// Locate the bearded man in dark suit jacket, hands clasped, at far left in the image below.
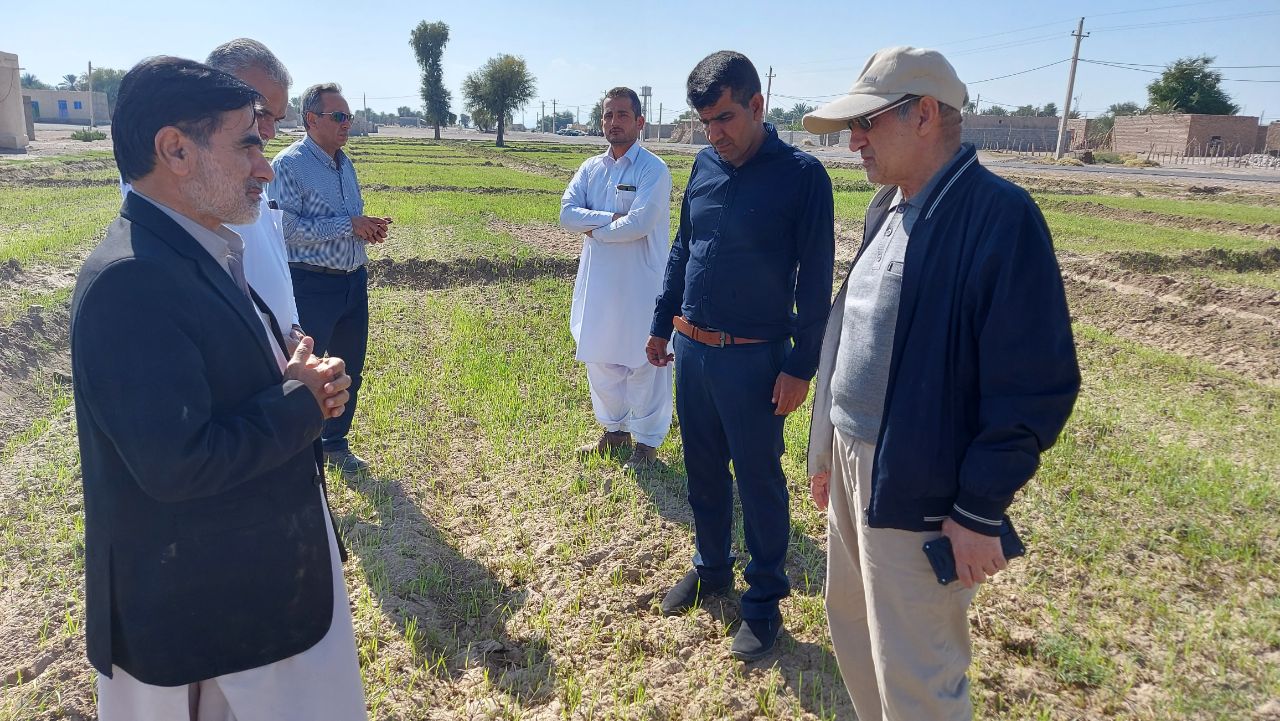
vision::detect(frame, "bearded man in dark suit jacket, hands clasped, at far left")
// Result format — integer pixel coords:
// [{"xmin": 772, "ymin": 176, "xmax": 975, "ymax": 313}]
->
[{"xmin": 70, "ymin": 58, "xmax": 365, "ymax": 721}]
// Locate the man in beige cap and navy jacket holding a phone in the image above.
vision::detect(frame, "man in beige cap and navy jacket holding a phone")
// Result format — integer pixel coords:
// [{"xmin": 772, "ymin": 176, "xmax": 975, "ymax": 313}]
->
[{"xmin": 804, "ymin": 47, "xmax": 1080, "ymax": 721}]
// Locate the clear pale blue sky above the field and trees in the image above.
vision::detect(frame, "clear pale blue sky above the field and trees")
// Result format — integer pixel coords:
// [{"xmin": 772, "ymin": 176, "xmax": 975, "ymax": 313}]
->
[{"xmin": 12, "ymin": 0, "xmax": 1280, "ymax": 122}]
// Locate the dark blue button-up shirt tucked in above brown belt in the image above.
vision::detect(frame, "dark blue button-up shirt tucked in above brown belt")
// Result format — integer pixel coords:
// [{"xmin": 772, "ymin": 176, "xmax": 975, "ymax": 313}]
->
[{"xmin": 650, "ymin": 124, "xmax": 836, "ymax": 380}]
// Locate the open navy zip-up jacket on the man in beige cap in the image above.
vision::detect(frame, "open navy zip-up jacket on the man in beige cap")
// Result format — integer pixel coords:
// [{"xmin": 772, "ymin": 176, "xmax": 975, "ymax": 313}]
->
[{"xmin": 809, "ymin": 145, "xmax": 1080, "ymax": 535}]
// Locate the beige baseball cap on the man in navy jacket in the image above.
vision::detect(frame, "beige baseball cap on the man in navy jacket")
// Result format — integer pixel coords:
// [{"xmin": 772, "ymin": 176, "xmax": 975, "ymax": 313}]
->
[{"xmin": 801, "ymin": 45, "xmax": 969, "ymax": 133}]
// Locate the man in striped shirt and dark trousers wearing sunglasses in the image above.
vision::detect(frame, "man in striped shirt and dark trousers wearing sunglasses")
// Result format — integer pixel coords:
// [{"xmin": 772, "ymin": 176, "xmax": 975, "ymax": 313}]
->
[{"xmin": 269, "ymin": 83, "xmax": 392, "ymax": 476}]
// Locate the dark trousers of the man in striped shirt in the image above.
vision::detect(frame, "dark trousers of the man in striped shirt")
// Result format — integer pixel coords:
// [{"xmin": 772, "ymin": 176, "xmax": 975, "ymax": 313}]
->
[{"xmin": 289, "ymin": 268, "xmax": 369, "ymax": 451}]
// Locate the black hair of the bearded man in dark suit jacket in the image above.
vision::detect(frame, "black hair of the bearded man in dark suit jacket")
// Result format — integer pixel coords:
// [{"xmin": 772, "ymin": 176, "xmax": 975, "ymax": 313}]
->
[{"xmin": 111, "ymin": 55, "xmax": 261, "ymax": 182}]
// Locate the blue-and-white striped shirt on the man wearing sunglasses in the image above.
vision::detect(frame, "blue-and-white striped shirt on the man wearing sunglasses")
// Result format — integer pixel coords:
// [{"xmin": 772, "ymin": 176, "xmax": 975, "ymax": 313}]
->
[{"xmin": 268, "ymin": 137, "xmax": 369, "ymax": 270}]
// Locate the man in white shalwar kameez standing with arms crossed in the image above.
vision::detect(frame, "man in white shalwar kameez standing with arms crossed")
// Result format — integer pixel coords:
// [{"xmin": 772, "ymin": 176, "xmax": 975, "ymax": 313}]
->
[{"xmin": 561, "ymin": 87, "xmax": 672, "ymax": 470}]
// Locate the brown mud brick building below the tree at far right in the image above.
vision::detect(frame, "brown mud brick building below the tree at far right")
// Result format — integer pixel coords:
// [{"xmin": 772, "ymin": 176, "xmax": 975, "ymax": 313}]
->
[{"xmin": 1112, "ymin": 113, "xmax": 1258, "ymax": 156}]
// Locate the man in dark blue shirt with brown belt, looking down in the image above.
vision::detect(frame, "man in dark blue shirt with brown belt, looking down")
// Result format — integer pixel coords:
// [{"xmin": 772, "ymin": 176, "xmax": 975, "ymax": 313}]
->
[{"xmin": 646, "ymin": 50, "xmax": 835, "ymax": 661}]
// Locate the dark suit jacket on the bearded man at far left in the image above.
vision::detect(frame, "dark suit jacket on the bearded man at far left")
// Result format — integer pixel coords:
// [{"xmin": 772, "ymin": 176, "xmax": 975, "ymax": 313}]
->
[{"xmin": 70, "ymin": 193, "xmax": 334, "ymax": 686}]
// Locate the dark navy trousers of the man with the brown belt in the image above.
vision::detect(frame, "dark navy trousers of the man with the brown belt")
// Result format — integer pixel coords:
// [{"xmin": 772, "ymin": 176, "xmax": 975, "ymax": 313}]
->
[{"xmin": 675, "ymin": 333, "xmax": 791, "ymax": 619}]
